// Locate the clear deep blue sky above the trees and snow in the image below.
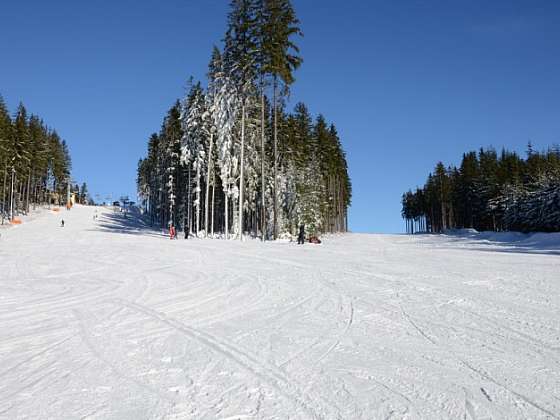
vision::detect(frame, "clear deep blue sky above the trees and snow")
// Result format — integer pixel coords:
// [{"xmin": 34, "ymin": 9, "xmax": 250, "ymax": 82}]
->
[{"xmin": 0, "ymin": 0, "xmax": 560, "ymax": 232}]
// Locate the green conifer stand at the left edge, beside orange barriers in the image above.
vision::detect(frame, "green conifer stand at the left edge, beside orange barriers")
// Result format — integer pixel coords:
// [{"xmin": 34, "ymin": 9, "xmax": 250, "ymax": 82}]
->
[{"xmin": 0, "ymin": 96, "xmax": 79, "ymax": 223}]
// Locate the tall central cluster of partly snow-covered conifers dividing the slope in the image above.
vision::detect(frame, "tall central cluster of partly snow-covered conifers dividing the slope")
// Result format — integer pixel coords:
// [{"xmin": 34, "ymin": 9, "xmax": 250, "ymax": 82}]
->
[{"xmin": 137, "ymin": 0, "xmax": 351, "ymax": 239}]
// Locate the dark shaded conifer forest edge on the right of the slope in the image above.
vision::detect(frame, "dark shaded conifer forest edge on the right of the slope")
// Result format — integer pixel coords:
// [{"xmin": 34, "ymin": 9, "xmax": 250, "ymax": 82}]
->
[{"xmin": 402, "ymin": 143, "xmax": 560, "ymax": 233}]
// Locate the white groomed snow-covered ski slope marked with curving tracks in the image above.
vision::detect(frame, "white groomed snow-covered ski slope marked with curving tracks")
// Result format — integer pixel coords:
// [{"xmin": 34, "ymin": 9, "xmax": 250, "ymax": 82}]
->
[{"xmin": 0, "ymin": 207, "xmax": 560, "ymax": 419}]
